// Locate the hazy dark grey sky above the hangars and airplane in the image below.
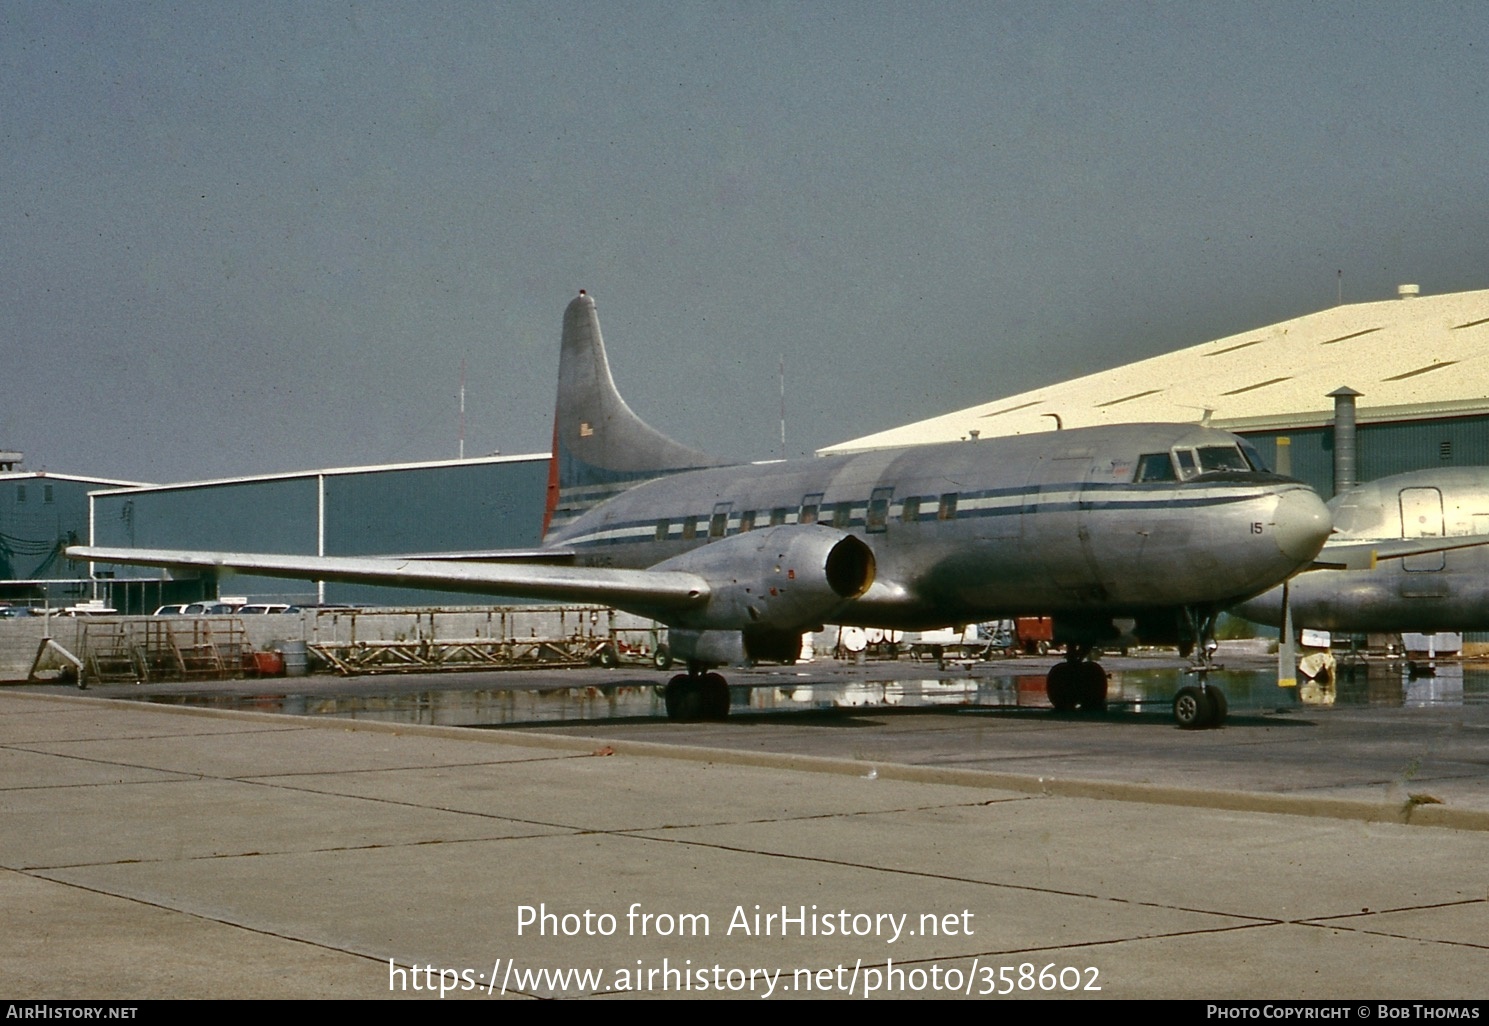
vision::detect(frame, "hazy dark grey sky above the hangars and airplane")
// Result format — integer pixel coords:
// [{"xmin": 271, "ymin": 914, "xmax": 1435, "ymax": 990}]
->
[{"xmin": 0, "ymin": 0, "xmax": 1489, "ymax": 481}]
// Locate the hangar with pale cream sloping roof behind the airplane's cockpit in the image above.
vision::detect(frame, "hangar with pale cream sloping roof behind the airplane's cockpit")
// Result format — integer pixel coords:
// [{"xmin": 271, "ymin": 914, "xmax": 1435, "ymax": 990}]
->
[{"xmin": 820, "ymin": 284, "xmax": 1489, "ymax": 496}]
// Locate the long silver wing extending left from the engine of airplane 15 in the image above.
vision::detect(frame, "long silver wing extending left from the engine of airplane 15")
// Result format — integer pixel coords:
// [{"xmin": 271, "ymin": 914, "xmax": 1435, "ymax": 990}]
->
[{"xmin": 67, "ymin": 545, "xmax": 709, "ymax": 615}]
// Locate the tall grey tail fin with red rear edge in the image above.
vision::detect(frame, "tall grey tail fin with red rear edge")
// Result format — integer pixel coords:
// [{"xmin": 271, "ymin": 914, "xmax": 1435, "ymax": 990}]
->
[{"xmin": 543, "ymin": 290, "xmax": 727, "ymax": 535}]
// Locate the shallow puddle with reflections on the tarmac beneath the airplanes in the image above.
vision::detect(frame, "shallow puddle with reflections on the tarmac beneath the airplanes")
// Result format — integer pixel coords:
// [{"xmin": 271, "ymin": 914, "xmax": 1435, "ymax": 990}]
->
[{"xmin": 141, "ymin": 664, "xmax": 1489, "ymax": 727}]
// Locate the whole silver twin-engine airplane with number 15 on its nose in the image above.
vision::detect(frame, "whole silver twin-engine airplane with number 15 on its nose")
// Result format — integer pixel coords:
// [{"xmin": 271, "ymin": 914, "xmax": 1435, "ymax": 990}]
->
[{"xmin": 68, "ymin": 290, "xmax": 1331, "ymax": 727}]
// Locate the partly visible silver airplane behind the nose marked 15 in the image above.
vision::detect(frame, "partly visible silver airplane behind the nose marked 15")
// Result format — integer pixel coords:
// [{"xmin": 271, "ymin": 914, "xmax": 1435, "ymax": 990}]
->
[{"xmin": 1231, "ymin": 466, "xmax": 1489, "ymax": 634}]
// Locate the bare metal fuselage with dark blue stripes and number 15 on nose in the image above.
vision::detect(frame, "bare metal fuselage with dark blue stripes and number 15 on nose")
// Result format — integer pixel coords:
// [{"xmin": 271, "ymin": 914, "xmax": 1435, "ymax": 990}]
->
[{"xmin": 546, "ymin": 424, "xmax": 1328, "ymax": 628}]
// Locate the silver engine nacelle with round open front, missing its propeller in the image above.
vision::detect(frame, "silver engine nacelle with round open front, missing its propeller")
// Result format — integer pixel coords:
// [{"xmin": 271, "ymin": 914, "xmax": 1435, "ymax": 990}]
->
[{"xmin": 652, "ymin": 524, "xmax": 874, "ymax": 633}]
